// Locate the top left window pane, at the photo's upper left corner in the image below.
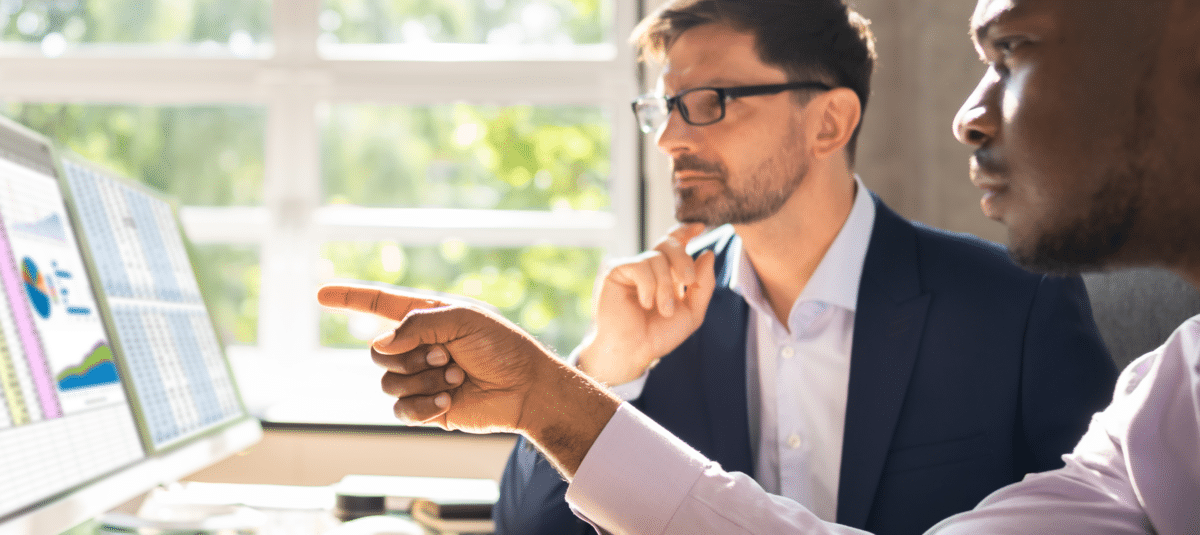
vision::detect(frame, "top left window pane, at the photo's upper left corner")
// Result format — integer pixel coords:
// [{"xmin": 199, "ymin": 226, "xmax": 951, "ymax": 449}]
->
[{"xmin": 0, "ymin": 0, "xmax": 271, "ymax": 55}]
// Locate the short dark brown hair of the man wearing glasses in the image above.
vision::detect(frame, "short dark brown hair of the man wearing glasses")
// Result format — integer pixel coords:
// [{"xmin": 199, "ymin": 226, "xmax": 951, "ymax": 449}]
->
[{"xmin": 630, "ymin": 0, "xmax": 875, "ymax": 166}]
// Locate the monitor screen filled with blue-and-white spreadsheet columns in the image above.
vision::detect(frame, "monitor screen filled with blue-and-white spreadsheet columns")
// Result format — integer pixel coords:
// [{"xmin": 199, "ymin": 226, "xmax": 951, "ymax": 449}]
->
[{"xmin": 62, "ymin": 156, "xmax": 246, "ymax": 451}]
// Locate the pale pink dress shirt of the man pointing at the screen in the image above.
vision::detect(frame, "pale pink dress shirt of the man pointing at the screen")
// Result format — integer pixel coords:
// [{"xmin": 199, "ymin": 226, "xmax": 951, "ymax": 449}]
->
[{"xmin": 566, "ymin": 315, "xmax": 1200, "ymax": 535}]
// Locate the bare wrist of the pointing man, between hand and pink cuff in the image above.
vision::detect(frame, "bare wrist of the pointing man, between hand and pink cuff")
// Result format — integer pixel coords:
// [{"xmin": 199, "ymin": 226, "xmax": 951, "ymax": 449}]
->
[{"xmin": 517, "ymin": 360, "xmax": 620, "ymax": 480}]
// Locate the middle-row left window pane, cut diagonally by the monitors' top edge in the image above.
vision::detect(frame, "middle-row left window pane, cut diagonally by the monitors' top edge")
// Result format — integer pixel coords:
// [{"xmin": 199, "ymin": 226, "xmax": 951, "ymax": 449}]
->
[{"xmin": 0, "ymin": 102, "xmax": 266, "ymax": 206}]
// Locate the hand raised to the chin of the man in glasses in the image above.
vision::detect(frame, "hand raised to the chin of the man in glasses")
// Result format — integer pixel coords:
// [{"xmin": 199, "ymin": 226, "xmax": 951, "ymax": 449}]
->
[{"xmin": 580, "ymin": 223, "xmax": 716, "ymax": 385}]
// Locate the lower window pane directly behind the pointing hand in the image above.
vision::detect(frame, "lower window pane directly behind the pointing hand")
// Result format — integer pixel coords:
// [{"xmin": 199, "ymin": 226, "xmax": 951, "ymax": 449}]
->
[{"xmin": 319, "ymin": 241, "xmax": 602, "ymax": 355}]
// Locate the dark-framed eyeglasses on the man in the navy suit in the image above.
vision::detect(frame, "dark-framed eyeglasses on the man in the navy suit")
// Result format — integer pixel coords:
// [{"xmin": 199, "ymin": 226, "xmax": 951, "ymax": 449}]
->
[{"xmin": 632, "ymin": 82, "xmax": 833, "ymax": 133}]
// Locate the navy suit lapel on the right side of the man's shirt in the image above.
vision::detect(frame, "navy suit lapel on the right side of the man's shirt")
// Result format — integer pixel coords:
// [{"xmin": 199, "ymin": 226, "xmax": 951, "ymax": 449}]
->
[{"xmin": 838, "ymin": 199, "xmax": 930, "ymax": 528}]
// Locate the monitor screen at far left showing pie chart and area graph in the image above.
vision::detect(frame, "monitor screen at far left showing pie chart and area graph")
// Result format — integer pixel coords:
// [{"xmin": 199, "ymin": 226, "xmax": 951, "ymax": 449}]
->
[{"xmin": 0, "ymin": 122, "xmax": 145, "ymax": 524}]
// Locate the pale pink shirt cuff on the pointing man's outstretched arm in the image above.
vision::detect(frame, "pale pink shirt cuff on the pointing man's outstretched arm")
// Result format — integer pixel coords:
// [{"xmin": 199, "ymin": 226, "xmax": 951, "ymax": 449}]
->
[{"xmin": 566, "ymin": 403, "xmax": 709, "ymax": 533}]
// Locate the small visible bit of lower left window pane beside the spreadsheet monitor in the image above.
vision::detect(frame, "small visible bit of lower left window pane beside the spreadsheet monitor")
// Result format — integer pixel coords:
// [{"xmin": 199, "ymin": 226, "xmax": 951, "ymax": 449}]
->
[{"xmin": 191, "ymin": 245, "xmax": 262, "ymax": 345}]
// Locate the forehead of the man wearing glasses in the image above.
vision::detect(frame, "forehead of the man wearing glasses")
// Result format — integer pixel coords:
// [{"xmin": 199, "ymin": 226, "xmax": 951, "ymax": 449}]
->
[{"xmin": 661, "ymin": 24, "xmax": 787, "ymax": 90}]
